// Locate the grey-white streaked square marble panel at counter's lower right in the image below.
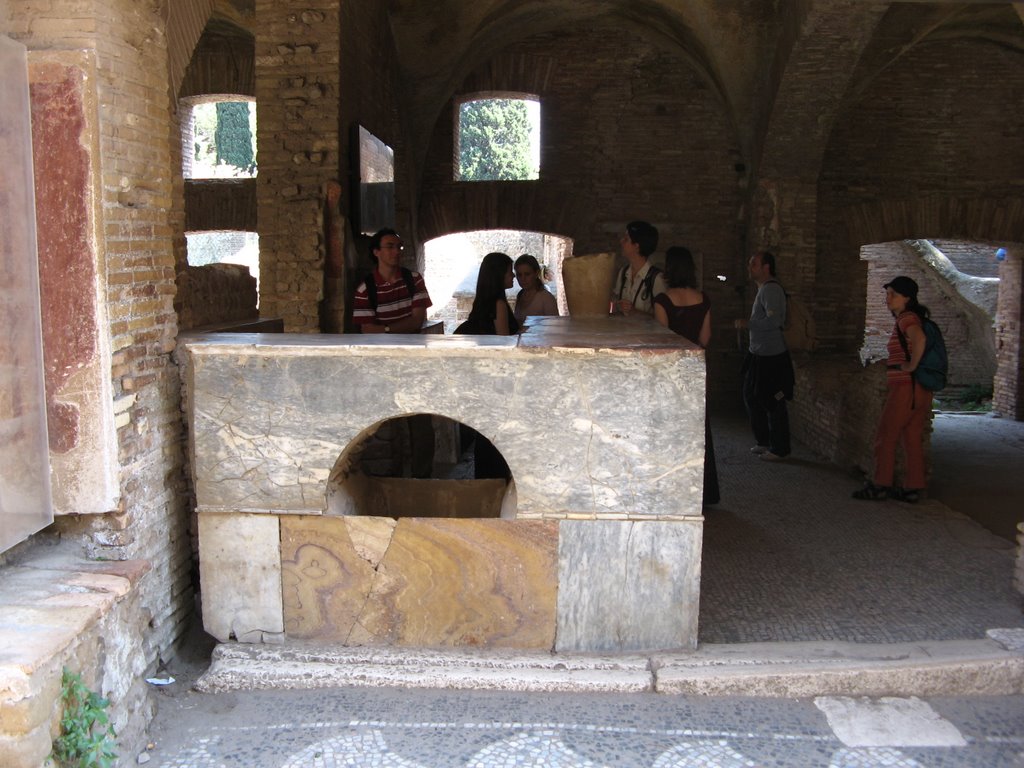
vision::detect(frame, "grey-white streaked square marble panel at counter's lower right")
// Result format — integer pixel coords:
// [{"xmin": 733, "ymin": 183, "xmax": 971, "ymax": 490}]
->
[{"xmin": 555, "ymin": 520, "xmax": 703, "ymax": 652}]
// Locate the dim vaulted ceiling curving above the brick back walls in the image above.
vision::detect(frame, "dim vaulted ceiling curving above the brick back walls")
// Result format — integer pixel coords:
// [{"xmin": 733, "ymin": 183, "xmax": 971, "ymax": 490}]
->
[{"xmin": 167, "ymin": 0, "xmax": 1024, "ymax": 172}]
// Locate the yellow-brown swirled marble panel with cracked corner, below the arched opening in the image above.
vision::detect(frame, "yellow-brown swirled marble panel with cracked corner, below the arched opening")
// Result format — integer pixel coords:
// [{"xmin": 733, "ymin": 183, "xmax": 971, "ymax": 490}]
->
[{"xmin": 281, "ymin": 515, "xmax": 558, "ymax": 650}]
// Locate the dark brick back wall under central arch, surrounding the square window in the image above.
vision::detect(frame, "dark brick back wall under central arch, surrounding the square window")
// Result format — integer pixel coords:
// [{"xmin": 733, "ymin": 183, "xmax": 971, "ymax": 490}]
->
[{"xmin": 419, "ymin": 23, "xmax": 753, "ymax": 387}]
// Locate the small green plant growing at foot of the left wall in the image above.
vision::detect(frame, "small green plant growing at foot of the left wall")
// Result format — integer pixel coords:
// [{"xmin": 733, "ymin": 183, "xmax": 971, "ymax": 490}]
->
[{"xmin": 50, "ymin": 667, "xmax": 118, "ymax": 768}]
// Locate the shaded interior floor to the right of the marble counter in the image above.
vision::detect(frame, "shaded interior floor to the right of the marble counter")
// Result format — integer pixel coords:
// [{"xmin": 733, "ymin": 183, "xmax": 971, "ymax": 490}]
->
[{"xmin": 699, "ymin": 416, "xmax": 1024, "ymax": 643}]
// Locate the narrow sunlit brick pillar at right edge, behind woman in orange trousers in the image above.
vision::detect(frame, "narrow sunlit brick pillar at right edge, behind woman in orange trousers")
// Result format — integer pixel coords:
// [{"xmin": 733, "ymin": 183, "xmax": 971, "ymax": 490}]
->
[{"xmin": 992, "ymin": 246, "xmax": 1024, "ymax": 421}]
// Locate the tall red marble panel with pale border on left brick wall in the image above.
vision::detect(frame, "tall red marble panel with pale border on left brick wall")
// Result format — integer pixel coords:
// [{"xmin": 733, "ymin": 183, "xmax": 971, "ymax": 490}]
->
[{"xmin": 29, "ymin": 51, "xmax": 121, "ymax": 514}]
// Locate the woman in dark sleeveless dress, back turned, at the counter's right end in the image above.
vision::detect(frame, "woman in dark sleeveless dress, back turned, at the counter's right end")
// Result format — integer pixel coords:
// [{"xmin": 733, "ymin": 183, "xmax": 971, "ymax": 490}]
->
[{"xmin": 654, "ymin": 246, "xmax": 720, "ymax": 505}]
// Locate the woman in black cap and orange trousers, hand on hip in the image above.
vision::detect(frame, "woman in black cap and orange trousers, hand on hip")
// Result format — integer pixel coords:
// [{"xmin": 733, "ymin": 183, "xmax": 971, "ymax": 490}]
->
[{"xmin": 853, "ymin": 274, "xmax": 932, "ymax": 504}]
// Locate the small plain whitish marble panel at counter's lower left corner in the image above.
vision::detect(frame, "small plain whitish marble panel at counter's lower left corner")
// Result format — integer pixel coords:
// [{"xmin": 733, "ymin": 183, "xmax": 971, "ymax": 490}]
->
[{"xmin": 199, "ymin": 514, "xmax": 285, "ymax": 643}]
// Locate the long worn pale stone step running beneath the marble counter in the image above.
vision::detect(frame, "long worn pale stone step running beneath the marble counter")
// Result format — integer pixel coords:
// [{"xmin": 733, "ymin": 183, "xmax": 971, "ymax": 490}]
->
[{"xmin": 196, "ymin": 630, "xmax": 1024, "ymax": 697}]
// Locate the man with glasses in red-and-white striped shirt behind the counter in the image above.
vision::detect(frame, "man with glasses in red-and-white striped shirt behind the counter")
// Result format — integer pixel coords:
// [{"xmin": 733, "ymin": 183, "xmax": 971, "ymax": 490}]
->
[{"xmin": 352, "ymin": 229, "xmax": 434, "ymax": 478}]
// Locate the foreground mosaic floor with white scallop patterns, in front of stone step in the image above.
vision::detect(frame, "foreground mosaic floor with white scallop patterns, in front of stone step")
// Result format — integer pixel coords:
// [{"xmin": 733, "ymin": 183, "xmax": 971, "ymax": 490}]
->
[{"xmin": 147, "ymin": 689, "xmax": 1024, "ymax": 768}]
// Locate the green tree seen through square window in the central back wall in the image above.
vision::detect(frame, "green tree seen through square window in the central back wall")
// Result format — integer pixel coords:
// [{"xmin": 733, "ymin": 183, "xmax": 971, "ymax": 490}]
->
[{"xmin": 459, "ymin": 98, "xmax": 538, "ymax": 181}]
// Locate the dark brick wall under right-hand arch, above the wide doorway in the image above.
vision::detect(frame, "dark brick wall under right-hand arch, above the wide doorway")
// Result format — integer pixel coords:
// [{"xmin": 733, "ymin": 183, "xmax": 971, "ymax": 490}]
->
[{"xmin": 817, "ymin": 33, "xmax": 1024, "ymax": 347}]
